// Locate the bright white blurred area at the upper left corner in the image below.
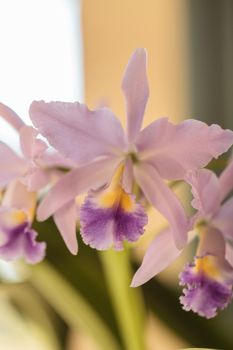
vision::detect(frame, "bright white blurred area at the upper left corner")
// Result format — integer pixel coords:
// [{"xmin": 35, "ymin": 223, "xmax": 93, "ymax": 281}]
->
[{"xmin": 0, "ymin": 0, "xmax": 83, "ymax": 149}]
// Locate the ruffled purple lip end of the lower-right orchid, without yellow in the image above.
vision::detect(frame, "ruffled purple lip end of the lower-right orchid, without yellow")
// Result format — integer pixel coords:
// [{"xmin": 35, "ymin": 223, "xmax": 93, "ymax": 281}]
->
[{"xmin": 179, "ymin": 264, "xmax": 232, "ymax": 319}]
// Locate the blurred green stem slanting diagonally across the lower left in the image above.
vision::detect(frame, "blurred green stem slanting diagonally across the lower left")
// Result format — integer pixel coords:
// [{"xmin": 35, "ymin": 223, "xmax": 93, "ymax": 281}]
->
[{"xmin": 31, "ymin": 262, "xmax": 120, "ymax": 350}]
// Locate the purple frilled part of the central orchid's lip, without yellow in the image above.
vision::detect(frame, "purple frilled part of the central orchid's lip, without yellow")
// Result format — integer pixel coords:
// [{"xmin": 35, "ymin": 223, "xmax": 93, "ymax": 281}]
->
[{"xmin": 80, "ymin": 195, "xmax": 148, "ymax": 250}]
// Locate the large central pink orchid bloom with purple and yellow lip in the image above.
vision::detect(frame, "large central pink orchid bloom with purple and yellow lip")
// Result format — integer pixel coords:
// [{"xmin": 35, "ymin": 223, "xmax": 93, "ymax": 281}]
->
[{"xmin": 30, "ymin": 49, "xmax": 233, "ymax": 253}]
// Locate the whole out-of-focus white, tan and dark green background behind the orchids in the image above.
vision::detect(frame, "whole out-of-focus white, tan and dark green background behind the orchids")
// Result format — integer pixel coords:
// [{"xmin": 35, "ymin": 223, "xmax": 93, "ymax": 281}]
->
[{"xmin": 0, "ymin": 0, "xmax": 233, "ymax": 350}]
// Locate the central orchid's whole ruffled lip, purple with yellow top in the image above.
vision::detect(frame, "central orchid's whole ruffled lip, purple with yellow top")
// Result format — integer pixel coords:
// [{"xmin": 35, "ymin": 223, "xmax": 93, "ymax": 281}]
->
[{"xmin": 80, "ymin": 189, "xmax": 147, "ymax": 250}]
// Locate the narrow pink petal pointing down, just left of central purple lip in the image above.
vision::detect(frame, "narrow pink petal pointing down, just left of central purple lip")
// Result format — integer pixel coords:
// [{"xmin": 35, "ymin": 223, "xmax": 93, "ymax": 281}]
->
[{"xmin": 53, "ymin": 201, "xmax": 78, "ymax": 255}]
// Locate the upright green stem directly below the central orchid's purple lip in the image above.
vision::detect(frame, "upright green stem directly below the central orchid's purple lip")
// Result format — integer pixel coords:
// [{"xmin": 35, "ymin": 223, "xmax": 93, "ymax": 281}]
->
[{"xmin": 100, "ymin": 249, "xmax": 145, "ymax": 350}]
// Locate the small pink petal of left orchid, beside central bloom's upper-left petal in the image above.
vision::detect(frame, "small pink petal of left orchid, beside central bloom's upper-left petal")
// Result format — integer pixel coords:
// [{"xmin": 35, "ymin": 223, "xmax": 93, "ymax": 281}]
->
[{"xmin": 20, "ymin": 126, "xmax": 47, "ymax": 161}]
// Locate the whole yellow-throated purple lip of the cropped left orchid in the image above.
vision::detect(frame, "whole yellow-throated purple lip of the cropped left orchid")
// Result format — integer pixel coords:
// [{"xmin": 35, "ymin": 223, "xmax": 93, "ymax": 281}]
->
[{"xmin": 0, "ymin": 181, "xmax": 46, "ymax": 264}]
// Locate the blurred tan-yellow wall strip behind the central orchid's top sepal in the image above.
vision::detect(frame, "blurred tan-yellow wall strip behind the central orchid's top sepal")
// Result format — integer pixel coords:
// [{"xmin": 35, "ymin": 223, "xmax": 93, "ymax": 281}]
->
[{"xmin": 82, "ymin": 0, "xmax": 190, "ymax": 123}]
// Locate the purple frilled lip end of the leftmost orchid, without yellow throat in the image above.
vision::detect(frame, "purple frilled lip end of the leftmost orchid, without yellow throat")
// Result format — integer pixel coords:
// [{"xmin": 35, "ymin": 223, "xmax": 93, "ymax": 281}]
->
[{"xmin": 0, "ymin": 222, "xmax": 46, "ymax": 264}]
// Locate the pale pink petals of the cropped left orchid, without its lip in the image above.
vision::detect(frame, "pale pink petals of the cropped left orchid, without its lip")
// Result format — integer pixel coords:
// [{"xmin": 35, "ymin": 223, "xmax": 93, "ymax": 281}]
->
[{"xmin": 0, "ymin": 103, "xmax": 78, "ymax": 254}]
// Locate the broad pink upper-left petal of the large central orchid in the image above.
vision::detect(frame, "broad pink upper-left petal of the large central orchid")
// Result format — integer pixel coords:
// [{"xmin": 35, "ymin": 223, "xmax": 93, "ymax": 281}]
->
[{"xmin": 30, "ymin": 101, "xmax": 125, "ymax": 165}]
